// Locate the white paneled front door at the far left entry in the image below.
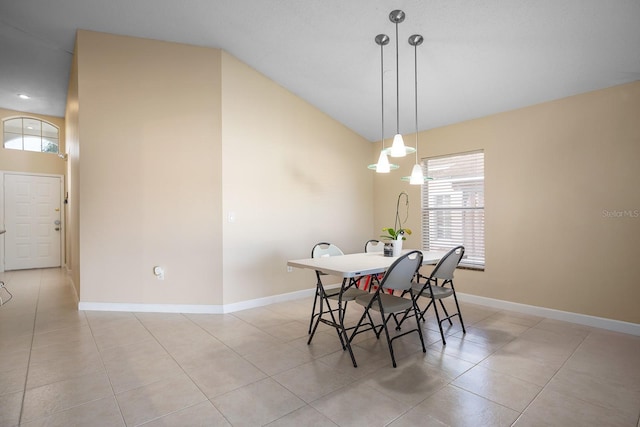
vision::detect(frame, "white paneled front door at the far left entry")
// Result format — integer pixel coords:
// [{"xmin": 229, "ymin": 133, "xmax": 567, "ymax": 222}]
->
[{"xmin": 4, "ymin": 173, "xmax": 62, "ymax": 270}]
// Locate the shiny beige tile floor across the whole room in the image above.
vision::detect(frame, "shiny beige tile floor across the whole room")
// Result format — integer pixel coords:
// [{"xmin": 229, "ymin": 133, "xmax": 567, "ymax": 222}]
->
[{"xmin": 0, "ymin": 269, "xmax": 640, "ymax": 427}]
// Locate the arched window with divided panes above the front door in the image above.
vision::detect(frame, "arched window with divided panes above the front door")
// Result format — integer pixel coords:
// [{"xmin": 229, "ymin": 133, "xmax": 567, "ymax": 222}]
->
[{"xmin": 2, "ymin": 117, "xmax": 60, "ymax": 154}]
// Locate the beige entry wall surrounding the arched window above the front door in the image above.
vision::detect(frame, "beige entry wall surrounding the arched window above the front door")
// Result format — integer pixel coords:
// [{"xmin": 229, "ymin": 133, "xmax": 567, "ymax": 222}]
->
[{"xmin": 0, "ymin": 108, "xmax": 66, "ymax": 175}]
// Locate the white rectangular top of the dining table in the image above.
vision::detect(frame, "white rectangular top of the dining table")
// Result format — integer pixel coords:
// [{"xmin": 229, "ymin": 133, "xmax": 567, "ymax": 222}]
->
[{"xmin": 287, "ymin": 249, "xmax": 446, "ymax": 277}]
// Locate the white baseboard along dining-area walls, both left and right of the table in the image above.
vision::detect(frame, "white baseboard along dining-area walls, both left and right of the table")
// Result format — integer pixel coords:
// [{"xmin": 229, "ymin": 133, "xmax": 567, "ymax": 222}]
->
[{"xmin": 78, "ymin": 288, "xmax": 640, "ymax": 336}]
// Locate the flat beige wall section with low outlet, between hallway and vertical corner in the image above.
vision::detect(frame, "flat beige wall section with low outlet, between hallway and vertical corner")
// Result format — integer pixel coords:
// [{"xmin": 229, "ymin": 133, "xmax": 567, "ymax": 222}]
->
[{"xmin": 72, "ymin": 31, "xmax": 222, "ymax": 304}]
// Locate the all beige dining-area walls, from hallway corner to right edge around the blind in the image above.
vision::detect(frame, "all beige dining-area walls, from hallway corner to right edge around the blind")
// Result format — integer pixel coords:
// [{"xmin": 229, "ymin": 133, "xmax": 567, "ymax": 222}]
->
[{"xmin": 62, "ymin": 31, "xmax": 640, "ymax": 323}]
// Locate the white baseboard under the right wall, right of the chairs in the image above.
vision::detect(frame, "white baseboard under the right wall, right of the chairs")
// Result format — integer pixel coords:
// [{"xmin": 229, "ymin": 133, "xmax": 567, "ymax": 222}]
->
[{"xmin": 456, "ymin": 292, "xmax": 640, "ymax": 336}]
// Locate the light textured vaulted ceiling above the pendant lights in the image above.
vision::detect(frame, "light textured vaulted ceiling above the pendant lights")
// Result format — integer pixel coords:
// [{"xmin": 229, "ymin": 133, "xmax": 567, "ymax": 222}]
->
[{"xmin": 0, "ymin": 0, "xmax": 640, "ymax": 141}]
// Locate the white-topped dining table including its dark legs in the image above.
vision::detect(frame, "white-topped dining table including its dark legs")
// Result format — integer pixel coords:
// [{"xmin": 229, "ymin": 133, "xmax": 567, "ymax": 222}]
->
[{"xmin": 287, "ymin": 249, "xmax": 446, "ymax": 367}]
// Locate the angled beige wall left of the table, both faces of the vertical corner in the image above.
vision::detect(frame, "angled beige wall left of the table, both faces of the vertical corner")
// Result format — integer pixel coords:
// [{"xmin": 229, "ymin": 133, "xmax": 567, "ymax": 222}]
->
[{"xmin": 74, "ymin": 31, "xmax": 373, "ymax": 305}]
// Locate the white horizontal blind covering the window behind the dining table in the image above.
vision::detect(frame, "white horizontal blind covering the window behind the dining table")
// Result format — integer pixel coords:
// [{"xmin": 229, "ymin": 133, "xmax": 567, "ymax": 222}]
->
[{"xmin": 422, "ymin": 151, "xmax": 484, "ymax": 268}]
